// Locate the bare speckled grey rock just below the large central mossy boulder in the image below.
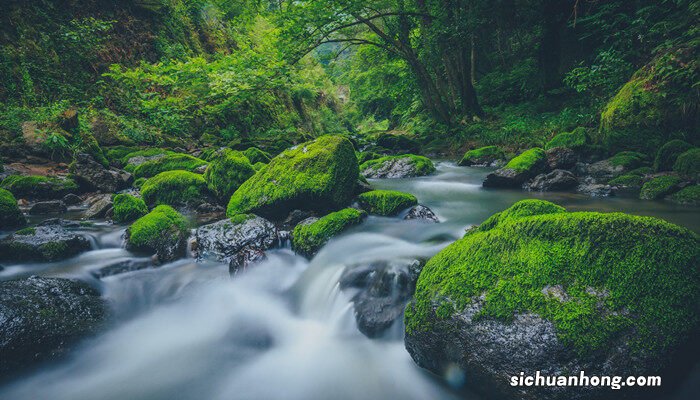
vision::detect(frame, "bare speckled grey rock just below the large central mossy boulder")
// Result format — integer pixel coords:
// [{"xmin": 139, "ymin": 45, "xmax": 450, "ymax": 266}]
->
[{"xmin": 195, "ymin": 214, "xmax": 278, "ymax": 270}]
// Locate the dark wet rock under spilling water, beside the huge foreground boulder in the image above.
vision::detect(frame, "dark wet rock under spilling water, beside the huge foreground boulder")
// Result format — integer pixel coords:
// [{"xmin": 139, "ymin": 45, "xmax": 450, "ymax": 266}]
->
[{"xmin": 340, "ymin": 260, "xmax": 422, "ymax": 337}]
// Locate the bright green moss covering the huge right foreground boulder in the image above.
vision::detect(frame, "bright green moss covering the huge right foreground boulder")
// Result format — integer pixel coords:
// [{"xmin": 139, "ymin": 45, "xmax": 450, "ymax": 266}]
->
[{"xmin": 405, "ymin": 200, "xmax": 700, "ymax": 354}]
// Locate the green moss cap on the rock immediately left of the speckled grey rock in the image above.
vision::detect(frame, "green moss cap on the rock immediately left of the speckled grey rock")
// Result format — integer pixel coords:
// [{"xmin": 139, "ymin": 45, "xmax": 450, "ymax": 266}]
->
[{"xmin": 127, "ymin": 205, "xmax": 187, "ymax": 251}]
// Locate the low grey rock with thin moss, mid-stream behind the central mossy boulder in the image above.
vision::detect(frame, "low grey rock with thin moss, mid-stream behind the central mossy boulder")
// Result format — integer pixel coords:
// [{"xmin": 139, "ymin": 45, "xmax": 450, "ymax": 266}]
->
[{"xmin": 360, "ymin": 154, "xmax": 435, "ymax": 179}]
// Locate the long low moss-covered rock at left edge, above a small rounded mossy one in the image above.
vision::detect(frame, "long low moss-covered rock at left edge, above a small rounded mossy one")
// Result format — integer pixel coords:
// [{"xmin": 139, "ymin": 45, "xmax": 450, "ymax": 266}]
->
[{"xmin": 0, "ymin": 175, "xmax": 78, "ymax": 200}]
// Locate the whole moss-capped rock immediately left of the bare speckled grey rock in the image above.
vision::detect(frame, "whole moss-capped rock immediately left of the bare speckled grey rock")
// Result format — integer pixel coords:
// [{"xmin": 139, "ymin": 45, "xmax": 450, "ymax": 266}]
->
[{"xmin": 126, "ymin": 205, "xmax": 189, "ymax": 261}]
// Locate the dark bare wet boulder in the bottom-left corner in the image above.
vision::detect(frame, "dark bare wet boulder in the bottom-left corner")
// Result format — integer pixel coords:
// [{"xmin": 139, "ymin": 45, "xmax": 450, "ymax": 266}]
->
[{"xmin": 0, "ymin": 276, "xmax": 108, "ymax": 377}]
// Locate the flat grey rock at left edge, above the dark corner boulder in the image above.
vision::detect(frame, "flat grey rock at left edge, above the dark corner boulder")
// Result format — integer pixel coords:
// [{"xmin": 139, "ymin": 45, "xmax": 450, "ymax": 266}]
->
[{"xmin": 0, "ymin": 220, "xmax": 91, "ymax": 262}]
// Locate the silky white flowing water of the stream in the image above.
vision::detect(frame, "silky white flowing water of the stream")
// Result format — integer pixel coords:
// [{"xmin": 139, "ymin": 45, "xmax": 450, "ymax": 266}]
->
[{"xmin": 0, "ymin": 162, "xmax": 700, "ymax": 400}]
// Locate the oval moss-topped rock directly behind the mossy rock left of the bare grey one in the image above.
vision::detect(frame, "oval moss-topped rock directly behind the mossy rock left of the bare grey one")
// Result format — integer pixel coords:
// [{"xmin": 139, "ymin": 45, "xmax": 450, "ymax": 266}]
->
[{"xmin": 141, "ymin": 171, "xmax": 209, "ymax": 206}]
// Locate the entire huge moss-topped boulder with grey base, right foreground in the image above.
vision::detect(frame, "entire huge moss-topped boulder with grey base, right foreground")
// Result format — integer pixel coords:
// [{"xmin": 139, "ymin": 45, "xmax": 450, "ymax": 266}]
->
[{"xmin": 405, "ymin": 200, "xmax": 700, "ymax": 399}]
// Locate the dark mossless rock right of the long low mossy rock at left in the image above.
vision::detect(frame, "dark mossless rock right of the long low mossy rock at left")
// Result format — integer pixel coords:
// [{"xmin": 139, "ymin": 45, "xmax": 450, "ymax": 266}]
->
[{"xmin": 71, "ymin": 154, "xmax": 133, "ymax": 193}]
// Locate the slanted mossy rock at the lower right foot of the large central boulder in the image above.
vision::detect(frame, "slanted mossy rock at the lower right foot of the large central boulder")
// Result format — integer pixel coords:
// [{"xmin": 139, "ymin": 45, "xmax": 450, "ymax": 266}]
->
[{"xmin": 292, "ymin": 208, "xmax": 367, "ymax": 256}]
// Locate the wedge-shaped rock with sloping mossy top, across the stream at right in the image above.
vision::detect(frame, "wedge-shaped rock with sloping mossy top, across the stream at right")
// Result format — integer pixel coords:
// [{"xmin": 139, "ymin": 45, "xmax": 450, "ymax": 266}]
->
[{"xmin": 484, "ymin": 147, "xmax": 548, "ymax": 188}]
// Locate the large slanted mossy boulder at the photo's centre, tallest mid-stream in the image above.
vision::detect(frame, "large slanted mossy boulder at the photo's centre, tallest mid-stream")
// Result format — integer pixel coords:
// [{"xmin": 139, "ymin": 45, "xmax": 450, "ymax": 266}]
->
[{"xmin": 227, "ymin": 136, "xmax": 358, "ymax": 218}]
